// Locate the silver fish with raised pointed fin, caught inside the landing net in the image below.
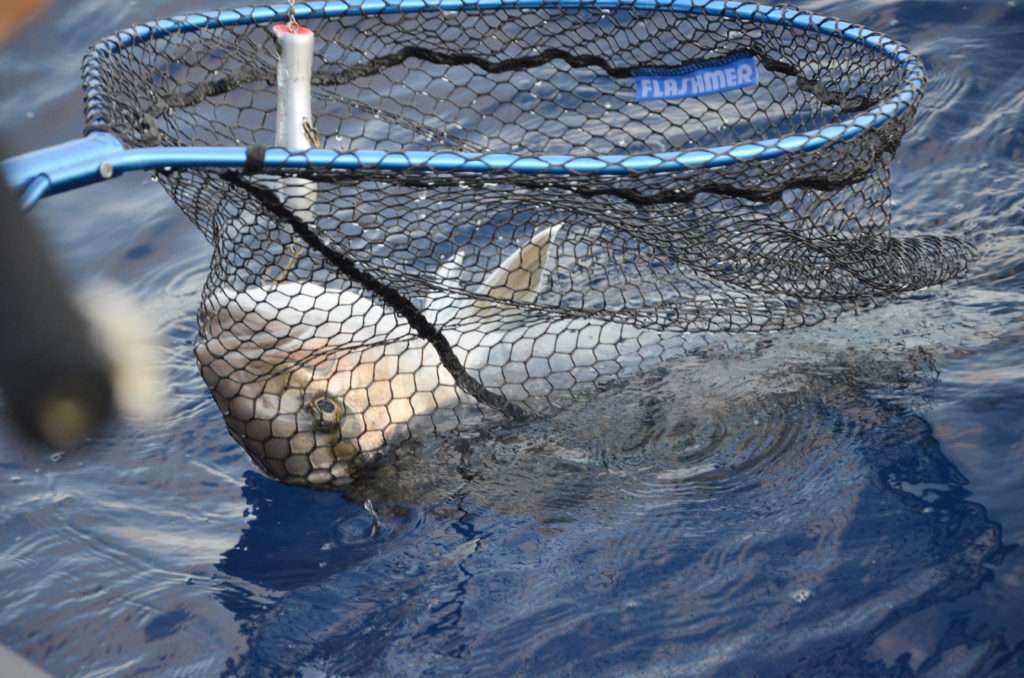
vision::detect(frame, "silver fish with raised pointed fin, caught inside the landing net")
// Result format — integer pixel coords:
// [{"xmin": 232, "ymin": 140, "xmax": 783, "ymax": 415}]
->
[{"xmin": 197, "ymin": 224, "xmax": 638, "ymax": 485}]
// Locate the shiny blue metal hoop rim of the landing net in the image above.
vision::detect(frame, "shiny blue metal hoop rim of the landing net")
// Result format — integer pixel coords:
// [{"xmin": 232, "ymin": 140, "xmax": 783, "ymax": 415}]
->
[{"xmin": 85, "ymin": 0, "xmax": 927, "ymax": 175}]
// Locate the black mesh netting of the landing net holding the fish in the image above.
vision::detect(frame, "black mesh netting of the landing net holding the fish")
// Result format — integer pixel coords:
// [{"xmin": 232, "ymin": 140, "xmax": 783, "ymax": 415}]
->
[{"xmin": 85, "ymin": 2, "xmax": 970, "ymax": 484}]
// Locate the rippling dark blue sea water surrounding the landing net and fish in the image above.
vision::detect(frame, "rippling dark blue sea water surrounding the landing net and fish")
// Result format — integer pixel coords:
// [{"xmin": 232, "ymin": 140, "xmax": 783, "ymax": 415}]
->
[{"xmin": 0, "ymin": 0, "xmax": 1024, "ymax": 676}]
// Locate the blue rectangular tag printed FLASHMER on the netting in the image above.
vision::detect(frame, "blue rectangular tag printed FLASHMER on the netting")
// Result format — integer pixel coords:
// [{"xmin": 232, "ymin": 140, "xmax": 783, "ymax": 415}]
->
[{"xmin": 633, "ymin": 55, "xmax": 758, "ymax": 101}]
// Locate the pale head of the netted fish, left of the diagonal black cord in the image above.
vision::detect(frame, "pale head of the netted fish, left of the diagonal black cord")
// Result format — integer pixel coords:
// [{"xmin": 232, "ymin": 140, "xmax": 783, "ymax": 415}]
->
[{"xmin": 196, "ymin": 284, "xmax": 457, "ymax": 486}]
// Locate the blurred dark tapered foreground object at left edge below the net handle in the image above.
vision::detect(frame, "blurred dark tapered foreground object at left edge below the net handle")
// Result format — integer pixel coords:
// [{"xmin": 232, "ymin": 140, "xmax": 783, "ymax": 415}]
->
[{"xmin": 0, "ymin": 164, "xmax": 114, "ymax": 448}]
